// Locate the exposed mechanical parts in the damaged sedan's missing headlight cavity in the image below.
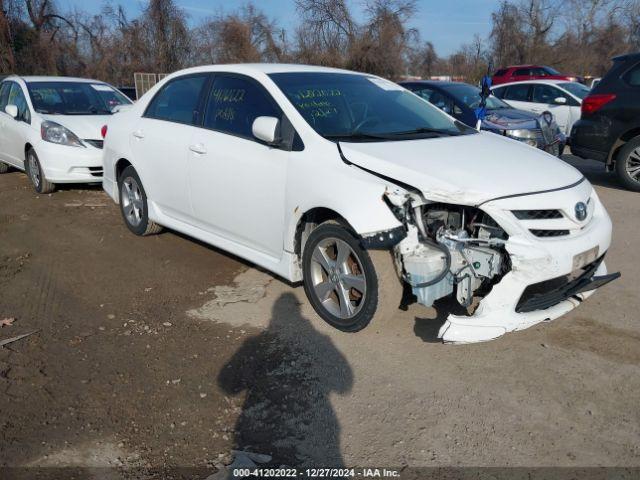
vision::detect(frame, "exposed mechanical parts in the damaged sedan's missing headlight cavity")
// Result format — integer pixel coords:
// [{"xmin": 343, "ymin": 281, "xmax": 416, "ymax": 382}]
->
[{"xmin": 386, "ymin": 186, "xmax": 511, "ymax": 307}]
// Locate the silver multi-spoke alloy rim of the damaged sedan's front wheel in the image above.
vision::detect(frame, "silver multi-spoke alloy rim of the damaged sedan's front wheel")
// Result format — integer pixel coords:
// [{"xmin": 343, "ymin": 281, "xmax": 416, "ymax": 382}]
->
[{"xmin": 311, "ymin": 237, "xmax": 367, "ymax": 320}]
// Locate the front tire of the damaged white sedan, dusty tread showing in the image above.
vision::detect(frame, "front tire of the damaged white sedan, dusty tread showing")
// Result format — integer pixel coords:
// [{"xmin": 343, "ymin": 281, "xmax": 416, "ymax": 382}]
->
[{"xmin": 302, "ymin": 223, "xmax": 402, "ymax": 332}]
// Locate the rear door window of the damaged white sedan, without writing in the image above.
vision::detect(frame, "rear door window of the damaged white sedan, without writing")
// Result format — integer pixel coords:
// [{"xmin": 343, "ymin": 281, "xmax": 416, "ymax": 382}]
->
[{"xmin": 144, "ymin": 75, "xmax": 207, "ymax": 125}]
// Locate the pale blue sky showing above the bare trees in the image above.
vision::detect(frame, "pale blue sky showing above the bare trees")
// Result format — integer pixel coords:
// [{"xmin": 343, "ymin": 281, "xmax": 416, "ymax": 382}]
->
[{"xmin": 57, "ymin": 0, "xmax": 499, "ymax": 56}]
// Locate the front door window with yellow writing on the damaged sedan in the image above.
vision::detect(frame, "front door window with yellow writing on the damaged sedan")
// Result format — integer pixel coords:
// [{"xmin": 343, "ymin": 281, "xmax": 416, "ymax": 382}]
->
[{"xmin": 204, "ymin": 75, "xmax": 281, "ymax": 139}]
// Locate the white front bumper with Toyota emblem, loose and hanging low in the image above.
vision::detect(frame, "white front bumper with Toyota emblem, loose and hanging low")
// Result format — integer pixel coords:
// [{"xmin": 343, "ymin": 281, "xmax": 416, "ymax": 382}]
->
[{"xmin": 438, "ymin": 182, "xmax": 618, "ymax": 343}]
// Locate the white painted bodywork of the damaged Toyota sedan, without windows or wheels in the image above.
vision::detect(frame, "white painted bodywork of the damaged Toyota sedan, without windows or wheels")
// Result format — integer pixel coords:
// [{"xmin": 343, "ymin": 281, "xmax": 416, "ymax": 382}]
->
[{"xmin": 103, "ymin": 64, "xmax": 611, "ymax": 342}]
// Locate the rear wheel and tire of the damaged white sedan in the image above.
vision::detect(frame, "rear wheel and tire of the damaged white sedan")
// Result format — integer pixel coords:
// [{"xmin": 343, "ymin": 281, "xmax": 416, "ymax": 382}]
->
[{"xmin": 118, "ymin": 166, "xmax": 162, "ymax": 236}]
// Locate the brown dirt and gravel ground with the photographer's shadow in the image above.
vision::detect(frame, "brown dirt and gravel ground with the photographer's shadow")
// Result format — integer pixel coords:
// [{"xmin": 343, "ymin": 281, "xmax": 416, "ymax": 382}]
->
[{"xmin": 0, "ymin": 156, "xmax": 640, "ymax": 478}]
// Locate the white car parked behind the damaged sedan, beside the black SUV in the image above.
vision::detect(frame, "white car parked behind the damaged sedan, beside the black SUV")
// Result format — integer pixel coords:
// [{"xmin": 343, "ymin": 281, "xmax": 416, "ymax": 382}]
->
[{"xmin": 491, "ymin": 80, "xmax": 589, "ymax": 142}]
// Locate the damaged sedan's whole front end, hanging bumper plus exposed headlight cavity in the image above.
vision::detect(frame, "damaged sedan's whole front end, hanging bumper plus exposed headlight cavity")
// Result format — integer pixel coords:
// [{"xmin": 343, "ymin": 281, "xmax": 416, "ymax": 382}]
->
[{"xmin": 372, "ymin": 182, "xmax": 620, "ymax": 343}]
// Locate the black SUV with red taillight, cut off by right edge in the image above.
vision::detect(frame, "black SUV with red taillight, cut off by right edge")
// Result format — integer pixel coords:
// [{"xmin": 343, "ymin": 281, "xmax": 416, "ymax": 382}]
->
[{"xmin": 571, "ymin": 53, "xmax": 640, "ymax": 192}]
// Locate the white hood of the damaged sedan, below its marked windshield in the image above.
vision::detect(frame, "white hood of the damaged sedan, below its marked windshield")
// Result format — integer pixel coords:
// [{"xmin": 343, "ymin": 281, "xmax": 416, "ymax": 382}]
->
[{"xmin": 339, "ymin": 132, "xmax": 582, "ymax": 205}]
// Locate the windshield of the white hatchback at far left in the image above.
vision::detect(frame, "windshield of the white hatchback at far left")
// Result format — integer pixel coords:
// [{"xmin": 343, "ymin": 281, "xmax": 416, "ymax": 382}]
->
[{"xmin": 27, "ymin": 82, "xmax": 131, "ymax": 115}]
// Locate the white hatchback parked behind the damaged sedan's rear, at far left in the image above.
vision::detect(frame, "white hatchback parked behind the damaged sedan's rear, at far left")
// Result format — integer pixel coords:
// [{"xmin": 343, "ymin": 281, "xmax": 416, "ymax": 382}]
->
[{"xmin": 0, "ymin": 75, "xmax": 131, "ymax": 193}]
